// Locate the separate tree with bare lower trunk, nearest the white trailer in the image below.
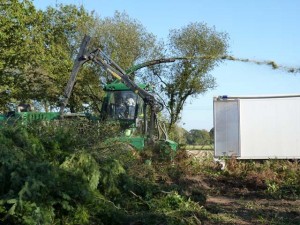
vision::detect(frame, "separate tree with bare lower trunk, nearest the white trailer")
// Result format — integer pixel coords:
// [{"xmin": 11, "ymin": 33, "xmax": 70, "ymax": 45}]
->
[{"xmin": 166, "ymin": 23, "xmax": 227, "ymax": 129}]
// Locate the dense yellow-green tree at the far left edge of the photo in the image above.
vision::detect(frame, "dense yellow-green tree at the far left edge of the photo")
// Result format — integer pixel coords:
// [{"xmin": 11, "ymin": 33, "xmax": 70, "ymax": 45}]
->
[{"xmin": 0, "ymin": 0, "xmax": 43, "ymax": 108}]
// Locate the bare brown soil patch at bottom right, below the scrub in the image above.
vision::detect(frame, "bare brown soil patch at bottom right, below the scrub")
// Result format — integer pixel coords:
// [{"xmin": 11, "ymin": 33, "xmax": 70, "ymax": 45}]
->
[{"xmin": 182, "ymin": 175, "xmax": 300, "ymax": 225}]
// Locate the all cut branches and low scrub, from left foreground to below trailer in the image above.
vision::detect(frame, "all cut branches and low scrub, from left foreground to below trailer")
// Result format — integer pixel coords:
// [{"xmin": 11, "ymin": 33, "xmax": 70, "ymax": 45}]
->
[{"xmin": 4, "ymin": 120, "xmax": 300, "ymax": 224}]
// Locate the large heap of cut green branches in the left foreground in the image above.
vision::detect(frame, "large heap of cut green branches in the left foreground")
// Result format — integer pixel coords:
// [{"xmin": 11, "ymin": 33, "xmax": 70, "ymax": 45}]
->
[{"xmin": 0, "ymin": 120, "xmax": 209, "ymax": 224}]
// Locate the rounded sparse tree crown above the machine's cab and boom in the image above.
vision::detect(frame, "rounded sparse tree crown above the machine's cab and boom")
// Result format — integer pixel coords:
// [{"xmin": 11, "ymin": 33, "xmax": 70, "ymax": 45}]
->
[{"xmin": 94, "ymin": 11, "xmax": 163, "ymax": 79}]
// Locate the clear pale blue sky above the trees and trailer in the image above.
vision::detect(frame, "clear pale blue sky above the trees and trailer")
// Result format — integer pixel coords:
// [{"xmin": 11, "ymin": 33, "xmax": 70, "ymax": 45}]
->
[{"xmin": 34, "ymin": 0, "xmax": 300, "ymax": 130}]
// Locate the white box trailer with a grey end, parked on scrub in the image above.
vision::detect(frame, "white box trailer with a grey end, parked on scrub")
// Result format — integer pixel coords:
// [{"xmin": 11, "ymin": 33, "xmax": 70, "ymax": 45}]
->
[{"xmin": 214, "ymin": 95, "xmax": 300, "ymax": 159}]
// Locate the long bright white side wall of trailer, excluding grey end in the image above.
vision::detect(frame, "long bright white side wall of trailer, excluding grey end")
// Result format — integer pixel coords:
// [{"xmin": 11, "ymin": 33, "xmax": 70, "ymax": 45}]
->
[{"xmin": 239, "ymin": 97, "xmax": 300, "ymax": 159}]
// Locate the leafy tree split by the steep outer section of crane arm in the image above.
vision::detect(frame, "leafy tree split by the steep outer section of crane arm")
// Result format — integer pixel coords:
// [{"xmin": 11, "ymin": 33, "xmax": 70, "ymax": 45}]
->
[{"xmin": 41, "ymin": 5, "xmax": 99, "ymax": 112}]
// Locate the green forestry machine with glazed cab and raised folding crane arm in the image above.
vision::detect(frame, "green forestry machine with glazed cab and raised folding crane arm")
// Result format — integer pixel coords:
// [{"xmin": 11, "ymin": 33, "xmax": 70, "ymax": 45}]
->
[{"xmin": 0, "ymin": 36, "xmax": 177, "ymax": 151}]
